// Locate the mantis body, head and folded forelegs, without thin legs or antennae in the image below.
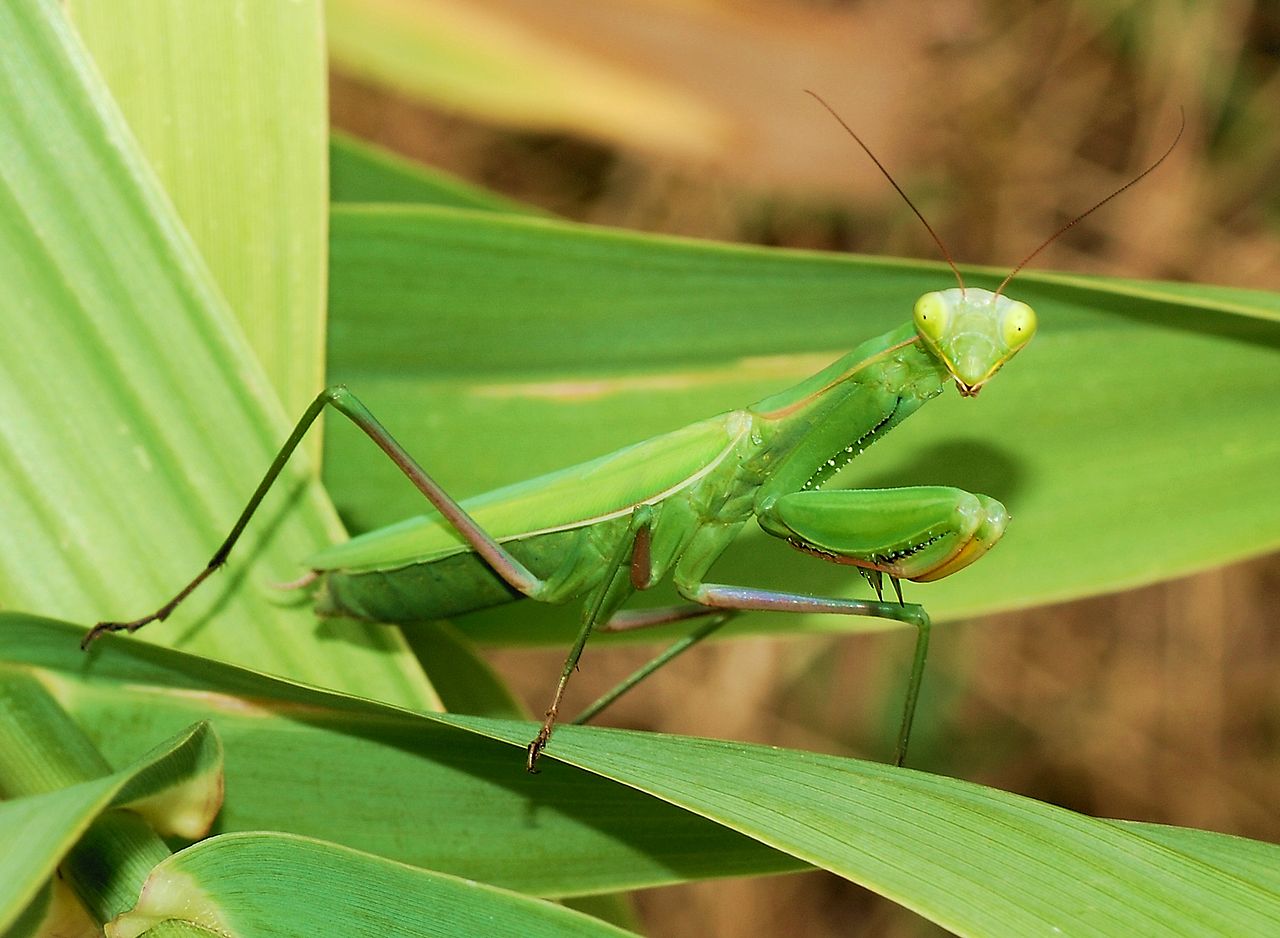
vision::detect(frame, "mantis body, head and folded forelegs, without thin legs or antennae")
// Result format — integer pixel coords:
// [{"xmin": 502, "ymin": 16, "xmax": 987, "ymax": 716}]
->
[{"xmin": 308, "ymin": 296, "xmax": 1034, "ymax": 623}]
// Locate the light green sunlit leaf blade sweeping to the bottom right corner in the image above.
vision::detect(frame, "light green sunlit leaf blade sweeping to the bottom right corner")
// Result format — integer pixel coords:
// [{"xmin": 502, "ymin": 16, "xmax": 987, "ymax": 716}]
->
[{"xmin": 439, "ymin": 715, "xmax": 1280, "ymax": 935}]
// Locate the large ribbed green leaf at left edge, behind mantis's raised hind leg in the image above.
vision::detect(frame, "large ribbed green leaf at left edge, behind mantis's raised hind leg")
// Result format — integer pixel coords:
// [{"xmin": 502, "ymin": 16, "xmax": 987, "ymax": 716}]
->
[{"xmin": 0, "ymin": 0, "xmax": 433, "ymax": 705}]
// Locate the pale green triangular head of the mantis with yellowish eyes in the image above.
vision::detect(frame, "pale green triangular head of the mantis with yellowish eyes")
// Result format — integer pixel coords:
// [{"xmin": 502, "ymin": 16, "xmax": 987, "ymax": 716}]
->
[{"xmin": 915, "ymin": 287, "xmax": 1036, "ymax": 397}]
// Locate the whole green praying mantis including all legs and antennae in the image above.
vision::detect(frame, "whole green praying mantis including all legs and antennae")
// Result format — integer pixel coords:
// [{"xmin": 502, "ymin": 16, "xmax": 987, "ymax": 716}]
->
[{"xmin": 82, "ymin": 95, "xmax": 1180, "ymax": 772}]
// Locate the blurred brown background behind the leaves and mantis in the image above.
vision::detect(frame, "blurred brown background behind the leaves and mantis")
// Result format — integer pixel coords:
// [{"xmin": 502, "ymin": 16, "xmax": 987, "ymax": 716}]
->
[{"xmin": 332, "ymin": 0, "xmax": 1280, "ymax": 937}]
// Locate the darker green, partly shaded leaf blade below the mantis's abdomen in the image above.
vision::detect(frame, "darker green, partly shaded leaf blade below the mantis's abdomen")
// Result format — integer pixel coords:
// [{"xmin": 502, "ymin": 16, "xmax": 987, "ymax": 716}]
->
[{"xmin": 0, "ymin": 613, "xmax": 803, "ymax": 897}]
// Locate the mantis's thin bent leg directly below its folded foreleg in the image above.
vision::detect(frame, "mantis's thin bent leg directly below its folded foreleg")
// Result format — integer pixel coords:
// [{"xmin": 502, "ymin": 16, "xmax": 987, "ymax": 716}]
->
[{"xmin": 677, "ymin": 584, "xmax": 931, "ymax": 765}]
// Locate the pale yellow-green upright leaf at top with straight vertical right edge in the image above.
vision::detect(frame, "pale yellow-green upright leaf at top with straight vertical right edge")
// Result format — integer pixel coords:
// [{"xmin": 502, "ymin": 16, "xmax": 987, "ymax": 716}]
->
[{"xmin": 68, "ymin": 0, "xmax": 328, "ymax": 424}]
